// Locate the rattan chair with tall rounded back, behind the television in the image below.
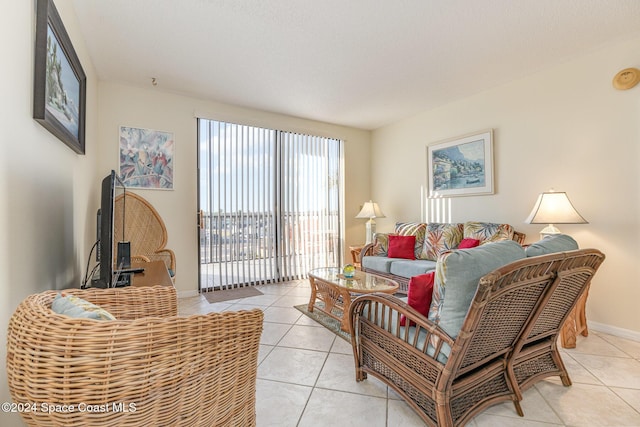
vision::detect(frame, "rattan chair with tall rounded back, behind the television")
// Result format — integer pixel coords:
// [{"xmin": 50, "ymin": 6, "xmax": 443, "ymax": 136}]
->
[{"xmin": 113, "ymin": 192, "xmax": 176, "ymax": 278}]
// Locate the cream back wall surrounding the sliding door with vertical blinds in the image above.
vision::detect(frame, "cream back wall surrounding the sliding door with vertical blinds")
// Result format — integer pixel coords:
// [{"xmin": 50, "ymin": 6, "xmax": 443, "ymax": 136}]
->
[{"xmin": 98, "ymin": 82, "xmax": 370, "ymax": 296}]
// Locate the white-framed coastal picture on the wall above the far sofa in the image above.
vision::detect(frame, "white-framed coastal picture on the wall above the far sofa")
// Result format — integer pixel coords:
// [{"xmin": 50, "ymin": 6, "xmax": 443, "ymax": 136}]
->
[{"xmin": 427, "ymin": 129, "xmax": 493, "ymax": 197}]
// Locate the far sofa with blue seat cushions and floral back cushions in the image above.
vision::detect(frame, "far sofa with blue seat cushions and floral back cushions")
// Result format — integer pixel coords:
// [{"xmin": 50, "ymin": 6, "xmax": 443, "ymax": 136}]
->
[{"xmin": 360, "ymin": 221, "xmax": 526, "ymax": 293}]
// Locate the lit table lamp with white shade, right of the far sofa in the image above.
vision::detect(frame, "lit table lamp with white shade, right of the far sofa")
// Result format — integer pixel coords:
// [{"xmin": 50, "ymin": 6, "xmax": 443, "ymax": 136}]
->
[{"xmin": 524, "ymin": 190, "xmax": 588, "ymax": 238}]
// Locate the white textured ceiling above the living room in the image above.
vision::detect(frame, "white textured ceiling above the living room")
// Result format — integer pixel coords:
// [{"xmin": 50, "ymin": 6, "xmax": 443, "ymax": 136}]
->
[{"xmin": 73, "ymin": 0, "xmax": 640, "ymax": 129}]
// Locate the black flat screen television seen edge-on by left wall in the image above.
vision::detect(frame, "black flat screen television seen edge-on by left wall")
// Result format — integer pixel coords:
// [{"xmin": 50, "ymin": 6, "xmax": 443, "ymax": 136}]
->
[{"xmin": 92, "ymin": 170, "xmax": 130, "ymax": 288}]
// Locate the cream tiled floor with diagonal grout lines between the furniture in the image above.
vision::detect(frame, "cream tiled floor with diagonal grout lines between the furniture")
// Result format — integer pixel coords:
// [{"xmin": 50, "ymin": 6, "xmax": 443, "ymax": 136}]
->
[{"xmin": 178, "ymin": 281, "xmax": 640, "ymax": 427}]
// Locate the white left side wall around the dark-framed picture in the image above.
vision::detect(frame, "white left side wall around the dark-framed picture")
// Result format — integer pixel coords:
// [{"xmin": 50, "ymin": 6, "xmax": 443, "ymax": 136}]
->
[{"xmin": 0, "ymin": 0, "xmax": 98, "ymax": 426}]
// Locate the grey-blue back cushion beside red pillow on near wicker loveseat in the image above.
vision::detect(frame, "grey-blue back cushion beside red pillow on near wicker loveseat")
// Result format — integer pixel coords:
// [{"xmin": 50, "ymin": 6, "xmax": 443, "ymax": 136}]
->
[{"xmin": 429, "ymin": 240, "xmax": 525, "ymax": 339}]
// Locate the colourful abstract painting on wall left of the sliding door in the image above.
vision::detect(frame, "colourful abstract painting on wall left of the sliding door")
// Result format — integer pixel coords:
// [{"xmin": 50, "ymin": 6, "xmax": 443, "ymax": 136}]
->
[{"xmin": 120, "ymin": 126, "xmax": 174, "ymax": 190}]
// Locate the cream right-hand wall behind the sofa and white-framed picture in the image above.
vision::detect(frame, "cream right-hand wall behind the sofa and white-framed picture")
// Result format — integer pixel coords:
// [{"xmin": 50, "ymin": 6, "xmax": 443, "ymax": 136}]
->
[{"xmin": 372, "ymin": 39, "xmax": 640, "ymax": 339}]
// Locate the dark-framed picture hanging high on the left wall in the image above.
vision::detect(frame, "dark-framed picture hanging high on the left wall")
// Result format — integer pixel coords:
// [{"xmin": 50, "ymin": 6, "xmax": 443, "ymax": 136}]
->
[{"xmin": 33, "ymin": 0, "xmax": 87, "ymax": 154}]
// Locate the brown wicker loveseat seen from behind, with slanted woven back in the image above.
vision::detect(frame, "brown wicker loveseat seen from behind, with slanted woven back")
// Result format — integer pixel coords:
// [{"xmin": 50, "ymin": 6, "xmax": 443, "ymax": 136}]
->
[{"xmin": 350, "ymin": 250, "xmax": 604, "ymax": 426}]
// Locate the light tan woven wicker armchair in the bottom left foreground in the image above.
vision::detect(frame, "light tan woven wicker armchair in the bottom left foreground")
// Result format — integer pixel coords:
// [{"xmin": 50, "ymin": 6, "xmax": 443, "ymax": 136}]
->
[{"xmin": 7, "ymin": 286, "xmax": 263, "ymax": 427}]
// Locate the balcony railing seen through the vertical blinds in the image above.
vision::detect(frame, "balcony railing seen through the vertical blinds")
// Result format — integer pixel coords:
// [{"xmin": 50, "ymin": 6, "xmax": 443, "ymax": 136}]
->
[{"xmin": 200, "ymin": 212, "xmax": 340, "ymax": 288}]
